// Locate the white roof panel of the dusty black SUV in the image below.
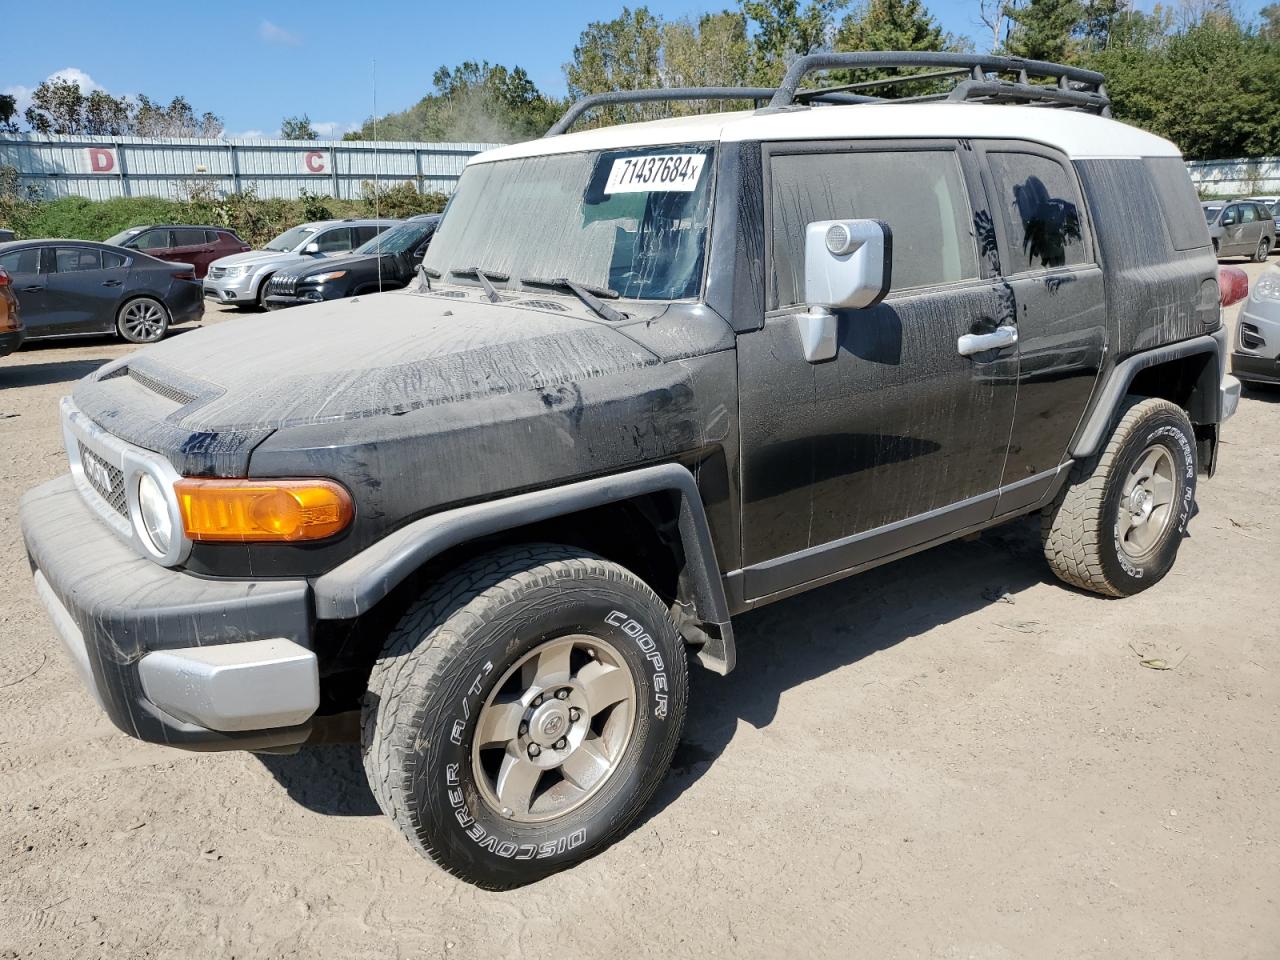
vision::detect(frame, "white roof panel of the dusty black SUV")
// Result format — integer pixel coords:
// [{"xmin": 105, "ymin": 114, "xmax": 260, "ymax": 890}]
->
[{"xmin": 470, "ymin": 102, "xmax": 1181, "ymax": 164}]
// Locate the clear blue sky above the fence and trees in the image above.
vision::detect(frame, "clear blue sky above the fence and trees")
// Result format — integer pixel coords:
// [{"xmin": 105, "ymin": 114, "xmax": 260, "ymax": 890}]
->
[{"xmin": 0, "ymin": 0, "xmax": 1263, "ymax": 137}]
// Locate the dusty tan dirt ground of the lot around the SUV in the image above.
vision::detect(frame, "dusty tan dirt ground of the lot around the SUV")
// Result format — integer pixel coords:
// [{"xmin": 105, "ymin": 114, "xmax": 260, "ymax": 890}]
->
[{"xmin": 0, "ymin": 266, "xmax": 1280, "ymax": 960}]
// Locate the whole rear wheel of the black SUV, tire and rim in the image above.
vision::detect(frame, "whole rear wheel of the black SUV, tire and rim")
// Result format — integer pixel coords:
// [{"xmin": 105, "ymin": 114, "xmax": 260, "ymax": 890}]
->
[{"xmin": 1042, "ymin": 398, "xmax": 1196, "ymax": 596}]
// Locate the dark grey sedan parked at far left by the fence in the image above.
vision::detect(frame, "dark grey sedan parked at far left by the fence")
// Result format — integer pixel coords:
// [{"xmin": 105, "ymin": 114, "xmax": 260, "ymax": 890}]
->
[{"xmin": 0, "ymin": 239, "xmax": 205, "ymax": 343}]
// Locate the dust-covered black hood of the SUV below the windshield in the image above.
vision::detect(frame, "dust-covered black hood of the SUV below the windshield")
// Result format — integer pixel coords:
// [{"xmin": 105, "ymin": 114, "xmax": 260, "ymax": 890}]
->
[{"xmin": 74, "ymin": 289, "xmax": 660, "ymax": 475}]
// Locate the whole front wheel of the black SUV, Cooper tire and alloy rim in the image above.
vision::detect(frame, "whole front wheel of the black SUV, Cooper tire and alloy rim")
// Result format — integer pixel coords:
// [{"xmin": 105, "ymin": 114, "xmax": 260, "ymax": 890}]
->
[{"xmin": 362, "ymin": 545, "xmax": 687, "ymax": 890}]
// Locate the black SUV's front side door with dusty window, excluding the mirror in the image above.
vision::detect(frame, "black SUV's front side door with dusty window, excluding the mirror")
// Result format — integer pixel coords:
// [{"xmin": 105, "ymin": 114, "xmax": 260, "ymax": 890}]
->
[{"xmin": 739, "ymin": 141, "xmax": 1018, "ymax": 598}]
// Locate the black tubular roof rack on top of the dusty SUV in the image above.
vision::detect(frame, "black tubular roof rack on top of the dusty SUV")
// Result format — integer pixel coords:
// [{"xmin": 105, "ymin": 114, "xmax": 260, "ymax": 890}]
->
[{"xmin": 545, "ymin": 50, "xmax": 1111, "ymax": 137}]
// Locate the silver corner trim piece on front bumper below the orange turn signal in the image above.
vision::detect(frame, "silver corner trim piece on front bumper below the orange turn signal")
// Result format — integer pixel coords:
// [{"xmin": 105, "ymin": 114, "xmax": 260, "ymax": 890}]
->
[{"xmin": 138, "ymin": 637, "xmax": 320, "ymax": 731}]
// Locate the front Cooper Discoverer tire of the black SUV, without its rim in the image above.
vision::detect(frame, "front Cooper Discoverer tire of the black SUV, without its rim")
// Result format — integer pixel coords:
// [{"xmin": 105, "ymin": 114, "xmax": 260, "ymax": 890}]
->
[{"xmin": 361, "ymin": 544, "xmax": 687, "ymax": 890}]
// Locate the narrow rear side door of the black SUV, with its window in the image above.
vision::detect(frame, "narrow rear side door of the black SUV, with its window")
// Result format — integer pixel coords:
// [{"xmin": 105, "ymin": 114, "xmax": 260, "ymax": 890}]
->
[{"xmin": 978, "ymin": 142, "xmax": 1107, "ymax": 513}]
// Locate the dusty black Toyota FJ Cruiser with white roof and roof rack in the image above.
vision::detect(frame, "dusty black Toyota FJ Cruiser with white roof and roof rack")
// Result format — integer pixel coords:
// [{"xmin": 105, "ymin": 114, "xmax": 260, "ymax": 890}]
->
[{"xmin": 22, "ymin": 54, "xmax": 1239, "ymax": 888}]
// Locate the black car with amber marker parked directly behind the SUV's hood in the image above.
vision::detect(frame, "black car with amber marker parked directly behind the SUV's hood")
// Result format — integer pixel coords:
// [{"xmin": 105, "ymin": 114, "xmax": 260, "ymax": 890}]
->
[{"xmin": 262, "ymin": 214, "xmax": 440, "ymax": 310}]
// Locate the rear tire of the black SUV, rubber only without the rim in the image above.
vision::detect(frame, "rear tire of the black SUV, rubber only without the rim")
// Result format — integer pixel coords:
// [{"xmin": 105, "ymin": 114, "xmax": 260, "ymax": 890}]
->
[{"xmin": 1041, "ymin": 397, "xmax": 1197, "ymax": 596}]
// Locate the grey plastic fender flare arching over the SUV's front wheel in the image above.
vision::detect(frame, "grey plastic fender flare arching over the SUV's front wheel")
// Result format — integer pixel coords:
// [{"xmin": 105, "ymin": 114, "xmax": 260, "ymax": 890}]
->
[{"xmin": 312, "ymin": 463, "xmax": 736, "ymax": 673}]
